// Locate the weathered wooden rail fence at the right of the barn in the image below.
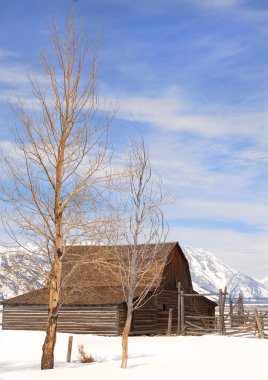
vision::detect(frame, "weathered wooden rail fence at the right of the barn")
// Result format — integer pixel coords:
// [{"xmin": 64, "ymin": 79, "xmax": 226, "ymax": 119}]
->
[{"xmin": 178, "ymin": 283, "xmax": 268, "ymax": 339}]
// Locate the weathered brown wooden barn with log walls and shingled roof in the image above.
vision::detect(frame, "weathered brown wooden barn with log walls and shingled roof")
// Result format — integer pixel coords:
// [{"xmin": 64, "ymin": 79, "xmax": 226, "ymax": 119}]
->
[{"xmin": 2, "ymin": 243, "xmax": 217, "ymax": 336}]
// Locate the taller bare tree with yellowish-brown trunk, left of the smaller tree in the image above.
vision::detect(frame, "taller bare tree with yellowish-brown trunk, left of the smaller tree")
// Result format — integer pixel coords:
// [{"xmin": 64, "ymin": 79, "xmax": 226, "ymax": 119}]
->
[{"xmin": 2, "ymin": 13, "xmax": 113, "ymax": 369}]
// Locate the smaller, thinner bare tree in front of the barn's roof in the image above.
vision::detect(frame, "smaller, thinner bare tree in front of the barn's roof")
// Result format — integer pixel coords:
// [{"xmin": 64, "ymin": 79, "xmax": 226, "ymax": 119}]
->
[{"xmin": 117, "ymin": 138, "xmax": 167, "ymax": 368}]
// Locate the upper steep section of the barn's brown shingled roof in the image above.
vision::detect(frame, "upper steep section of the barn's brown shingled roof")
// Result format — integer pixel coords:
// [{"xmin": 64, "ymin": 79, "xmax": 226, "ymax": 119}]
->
[{"xmin": 62, "ymin": 243, "xmax": 178, "ymax": 288}]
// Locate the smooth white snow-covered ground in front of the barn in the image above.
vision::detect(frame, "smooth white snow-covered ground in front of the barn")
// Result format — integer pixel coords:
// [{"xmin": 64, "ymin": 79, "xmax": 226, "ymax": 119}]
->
[{"xmin": 0, "ymin": 330, "xmax": 268, "ymax": 380}]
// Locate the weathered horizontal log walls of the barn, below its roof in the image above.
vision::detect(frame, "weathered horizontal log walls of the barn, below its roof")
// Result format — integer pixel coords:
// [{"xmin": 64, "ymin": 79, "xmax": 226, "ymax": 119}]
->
[{"xmin": 2, "ymin": 290, "xmax": 215, "ymax": 336}]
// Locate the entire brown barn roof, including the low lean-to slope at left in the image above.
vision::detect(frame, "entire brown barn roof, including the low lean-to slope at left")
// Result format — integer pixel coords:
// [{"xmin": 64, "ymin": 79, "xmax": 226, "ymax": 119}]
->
[{"xmin": 1, "ymin": 243, "xmax": 181, "ymax": 305}]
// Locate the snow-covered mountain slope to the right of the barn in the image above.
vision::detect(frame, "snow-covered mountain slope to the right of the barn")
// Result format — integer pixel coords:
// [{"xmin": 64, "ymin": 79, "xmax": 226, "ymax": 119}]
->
[{"xmin": 183, "ymin": 247, "xmax": 268, "ymax": 298}]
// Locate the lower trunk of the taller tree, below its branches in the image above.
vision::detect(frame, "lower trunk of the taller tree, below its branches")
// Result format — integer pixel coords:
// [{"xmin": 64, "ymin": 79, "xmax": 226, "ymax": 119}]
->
[{"xmin": 41, "ymin": 259, "xmax": 61, "ymax": 369}]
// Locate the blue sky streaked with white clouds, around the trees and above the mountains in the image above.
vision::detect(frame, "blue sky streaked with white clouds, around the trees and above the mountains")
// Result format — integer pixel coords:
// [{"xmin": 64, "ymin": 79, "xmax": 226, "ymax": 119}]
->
[{"xmin": 0, "ymin": 0, "xmax": 268, "ymax": 278}]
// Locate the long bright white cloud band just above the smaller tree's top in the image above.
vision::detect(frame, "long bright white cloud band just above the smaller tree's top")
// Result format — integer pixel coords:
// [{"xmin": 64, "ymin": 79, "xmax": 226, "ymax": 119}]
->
[{"xmin": 110, "ymin": 91, "xmax": 268, "ymax": 139}]
